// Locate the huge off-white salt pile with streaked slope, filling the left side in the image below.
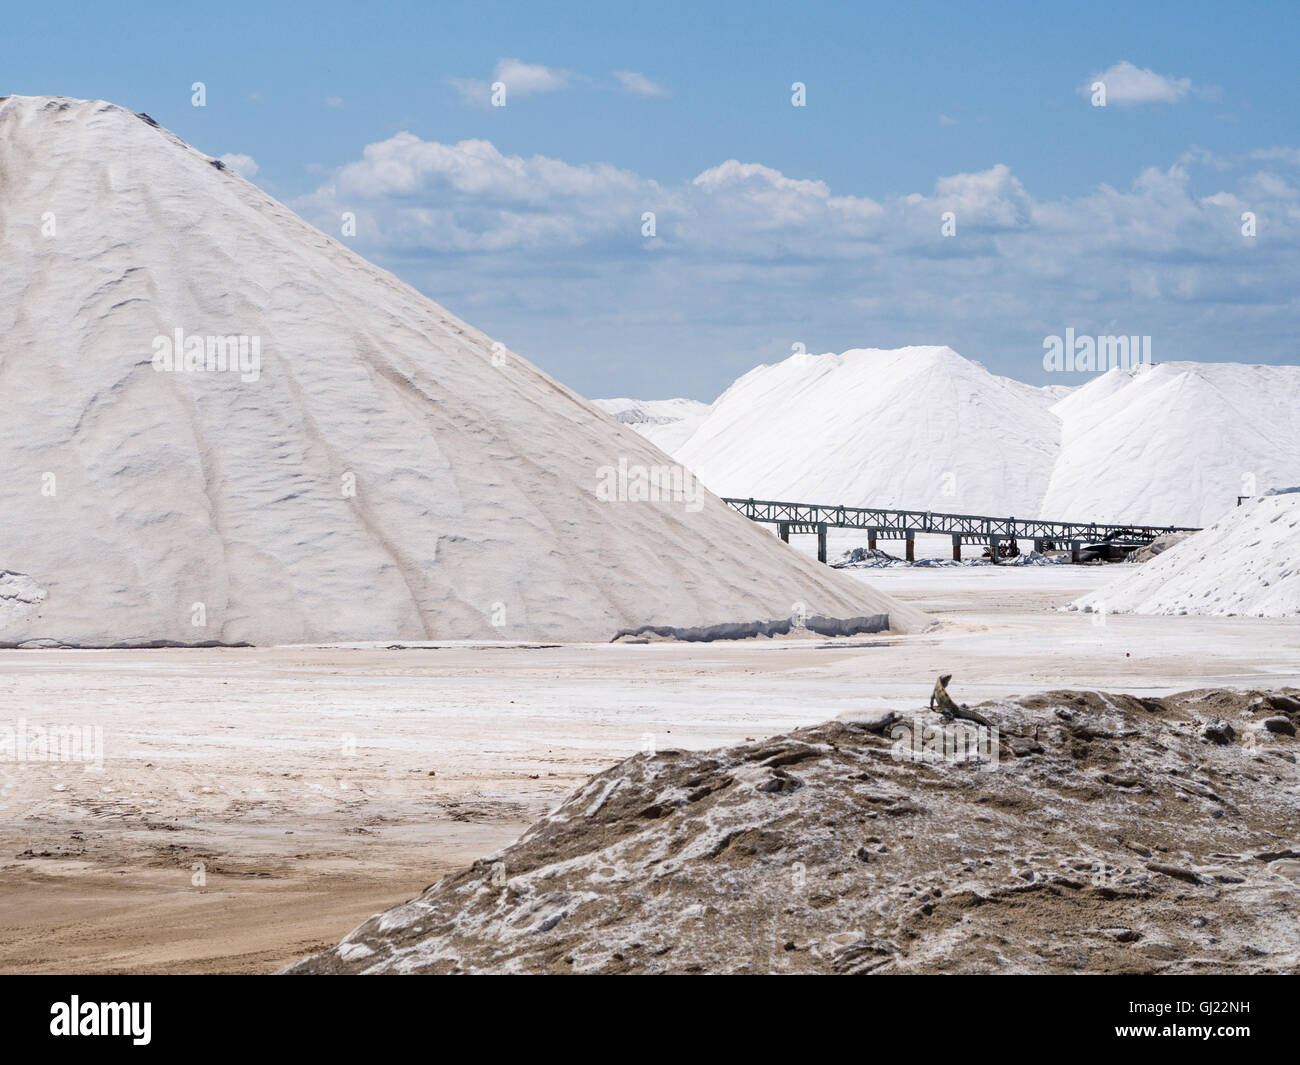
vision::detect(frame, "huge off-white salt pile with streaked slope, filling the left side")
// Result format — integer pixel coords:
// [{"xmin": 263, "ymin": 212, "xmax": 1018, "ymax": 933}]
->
[{"xmin": 0, "ymin": 96, "xmax": 927, "ymax": 646}]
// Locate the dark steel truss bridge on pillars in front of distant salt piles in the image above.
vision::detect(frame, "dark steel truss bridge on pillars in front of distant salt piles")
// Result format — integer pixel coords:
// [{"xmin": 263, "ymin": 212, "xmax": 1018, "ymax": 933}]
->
[{"xmin": 723, "ymin": 498, "xmax": 1199, "ymax": 562}]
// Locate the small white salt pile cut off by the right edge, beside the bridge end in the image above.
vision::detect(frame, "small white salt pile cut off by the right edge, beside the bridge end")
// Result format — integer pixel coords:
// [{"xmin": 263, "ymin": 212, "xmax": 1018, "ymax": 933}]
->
[{"xmin": 1073, "ymin": 489, "xmax": 1300, "ymax": 618}]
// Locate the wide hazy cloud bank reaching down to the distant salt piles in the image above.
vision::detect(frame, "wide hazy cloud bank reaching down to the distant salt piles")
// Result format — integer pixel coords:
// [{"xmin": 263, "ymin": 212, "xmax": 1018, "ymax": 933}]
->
[{"xmin": 295, "ymin": 133, "xmax": 1300, "ymax": 395}]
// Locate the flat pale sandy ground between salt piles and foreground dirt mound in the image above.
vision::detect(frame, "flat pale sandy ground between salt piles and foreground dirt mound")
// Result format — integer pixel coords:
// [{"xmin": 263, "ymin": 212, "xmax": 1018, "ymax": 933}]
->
[{"xmin": 0, "ymin": 567, "xmax": 1300, "ymax": 973}]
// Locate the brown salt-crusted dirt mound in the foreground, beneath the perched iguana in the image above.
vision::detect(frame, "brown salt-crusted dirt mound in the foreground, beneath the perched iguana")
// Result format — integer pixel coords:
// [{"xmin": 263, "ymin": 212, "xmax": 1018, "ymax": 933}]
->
[{"xmin": 287, "ymin": 689, "xmax": 1300, "ymax": 973}]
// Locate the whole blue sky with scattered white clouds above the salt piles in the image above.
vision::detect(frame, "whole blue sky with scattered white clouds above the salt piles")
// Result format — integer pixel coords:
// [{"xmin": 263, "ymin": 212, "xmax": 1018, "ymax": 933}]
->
[{"xmin": 10, "ymin": 3, "xmax": 1300, "ymax": 399}]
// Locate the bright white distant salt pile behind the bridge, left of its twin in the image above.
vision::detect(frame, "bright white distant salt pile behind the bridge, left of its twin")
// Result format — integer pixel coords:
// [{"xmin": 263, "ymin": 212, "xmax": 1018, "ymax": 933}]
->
[{"xmin": 675, "ymin": 347, "xmax": 1060, "ymax": 518}]
